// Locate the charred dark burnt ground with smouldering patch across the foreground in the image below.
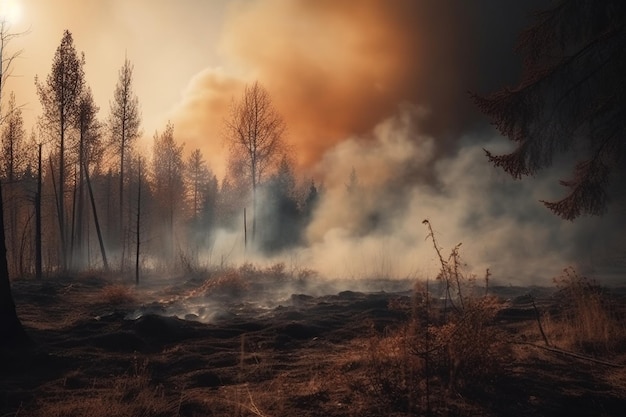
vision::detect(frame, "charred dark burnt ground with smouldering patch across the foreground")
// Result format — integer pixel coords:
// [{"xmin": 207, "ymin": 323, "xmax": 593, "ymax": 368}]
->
[{"xmin": 0, "ymin": 277, "xmax": 626, "ymax": 416}]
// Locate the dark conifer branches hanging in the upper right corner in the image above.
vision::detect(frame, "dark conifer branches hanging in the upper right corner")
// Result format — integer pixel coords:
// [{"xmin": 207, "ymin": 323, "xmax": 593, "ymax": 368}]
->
[{"xmin": 472, "ymin": 0, "xmax": 626, "ymax": 220}]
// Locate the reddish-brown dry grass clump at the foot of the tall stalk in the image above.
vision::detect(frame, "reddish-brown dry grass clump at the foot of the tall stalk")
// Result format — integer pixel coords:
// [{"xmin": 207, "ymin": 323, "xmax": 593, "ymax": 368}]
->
[{"xmin": 352, "ymin": 297, "xmax": 510, "ymax": 415}]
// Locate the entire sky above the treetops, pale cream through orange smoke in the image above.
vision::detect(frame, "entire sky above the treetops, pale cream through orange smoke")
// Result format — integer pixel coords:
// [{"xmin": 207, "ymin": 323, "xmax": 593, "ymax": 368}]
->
[{"xmin": 7, "ymin": 0, "xmax": 538, "ymax": 176}]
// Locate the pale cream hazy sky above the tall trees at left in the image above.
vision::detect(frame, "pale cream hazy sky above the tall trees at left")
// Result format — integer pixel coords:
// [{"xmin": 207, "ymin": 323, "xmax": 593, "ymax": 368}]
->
[{"xmin": 9, "ymin": 0, "xmax": 224, "ymax": 154}]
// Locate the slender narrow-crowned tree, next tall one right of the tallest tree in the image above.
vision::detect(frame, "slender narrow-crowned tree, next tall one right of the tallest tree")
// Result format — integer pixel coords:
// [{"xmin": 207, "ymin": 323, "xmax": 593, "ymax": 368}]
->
[{"xmin": 108, "ymin": 58, "xmax": 141, "ymax": 256}]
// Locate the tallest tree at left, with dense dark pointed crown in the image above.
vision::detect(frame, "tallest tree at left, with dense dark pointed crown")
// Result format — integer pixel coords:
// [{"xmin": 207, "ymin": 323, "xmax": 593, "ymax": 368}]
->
[{"xmin": 35, "ymin": 30, "xmax": 85, "ymax": 269}]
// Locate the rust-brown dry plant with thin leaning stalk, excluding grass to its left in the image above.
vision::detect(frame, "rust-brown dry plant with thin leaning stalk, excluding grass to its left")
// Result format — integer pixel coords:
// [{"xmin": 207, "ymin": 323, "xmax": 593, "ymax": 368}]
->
[{"xmin": 414, "ymin": 220, "xmax": 508, "ymax": 388}]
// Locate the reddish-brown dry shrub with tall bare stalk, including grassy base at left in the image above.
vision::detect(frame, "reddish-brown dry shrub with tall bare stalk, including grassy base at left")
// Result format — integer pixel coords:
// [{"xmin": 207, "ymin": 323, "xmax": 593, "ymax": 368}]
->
[{"xmin": 356, "ymin": 221, "xmax": 510, "ymax": 413}]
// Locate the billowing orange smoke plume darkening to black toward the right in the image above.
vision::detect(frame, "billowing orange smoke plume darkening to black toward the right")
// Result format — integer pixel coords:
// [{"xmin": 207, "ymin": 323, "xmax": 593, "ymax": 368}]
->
[{"xmin": 174, "ymin": 0, "xmax": 544, "ymax": 176}]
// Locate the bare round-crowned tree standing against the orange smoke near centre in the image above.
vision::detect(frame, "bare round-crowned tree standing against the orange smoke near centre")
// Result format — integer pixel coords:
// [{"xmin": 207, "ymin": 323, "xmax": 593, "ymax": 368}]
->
[{"xmin": 225, "ymin": 82, "xmax": 286, "ymax": 240}]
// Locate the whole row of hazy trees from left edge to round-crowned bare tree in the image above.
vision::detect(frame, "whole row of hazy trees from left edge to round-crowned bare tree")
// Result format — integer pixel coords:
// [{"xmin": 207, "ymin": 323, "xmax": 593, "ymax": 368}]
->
[{"xmin": 0, "ymin": 31, "xmax": 318, "ymax": 276}]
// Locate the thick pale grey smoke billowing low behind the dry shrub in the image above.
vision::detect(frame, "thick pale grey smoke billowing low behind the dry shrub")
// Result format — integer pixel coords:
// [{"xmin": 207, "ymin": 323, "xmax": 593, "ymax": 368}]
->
[{"xmin": 284, "ymin": 105, "xmax": 623, "ymax": 285}]
